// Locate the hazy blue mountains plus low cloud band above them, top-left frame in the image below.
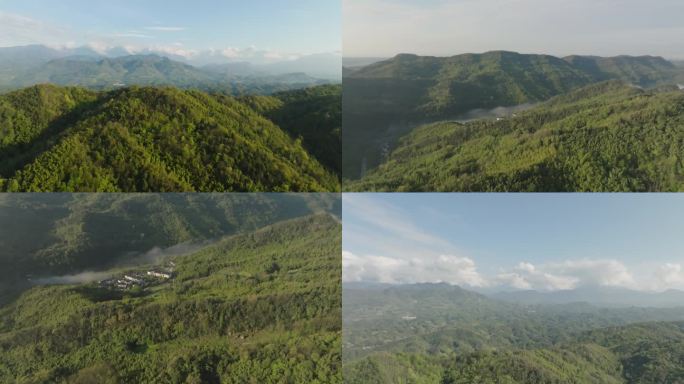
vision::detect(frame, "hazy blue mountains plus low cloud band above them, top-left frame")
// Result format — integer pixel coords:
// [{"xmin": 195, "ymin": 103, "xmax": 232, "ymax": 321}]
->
[{"xmin": 0, "ymin": 45, "xmax": 341, "ymax": 93}]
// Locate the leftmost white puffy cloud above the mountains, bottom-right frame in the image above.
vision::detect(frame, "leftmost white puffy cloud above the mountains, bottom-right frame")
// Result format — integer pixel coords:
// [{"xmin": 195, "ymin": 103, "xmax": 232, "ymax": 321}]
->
[{"xmin": 342, "ymin": 251, "xmax": 487, "ymax": 287}]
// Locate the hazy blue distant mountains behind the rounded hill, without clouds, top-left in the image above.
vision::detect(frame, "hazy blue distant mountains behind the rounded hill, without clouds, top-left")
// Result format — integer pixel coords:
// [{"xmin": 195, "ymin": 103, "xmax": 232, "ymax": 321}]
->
[{"xmin": 0, "ymin": 53, "xmax": 328, "ymax": 94}]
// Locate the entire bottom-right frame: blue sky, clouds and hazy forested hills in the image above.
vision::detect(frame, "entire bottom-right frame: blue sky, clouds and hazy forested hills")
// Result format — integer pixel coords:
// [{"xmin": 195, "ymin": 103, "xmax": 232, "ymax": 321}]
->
[{"xmin": 342, "ymin": 193, "xmax": 684, "ymax": 384}]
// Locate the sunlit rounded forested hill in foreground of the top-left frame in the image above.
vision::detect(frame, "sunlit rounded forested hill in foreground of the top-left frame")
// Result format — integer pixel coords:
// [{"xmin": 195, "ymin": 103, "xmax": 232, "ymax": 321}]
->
[{"xmin": 0, "ymin": 85, "xmax": 339, "ymax": 192}]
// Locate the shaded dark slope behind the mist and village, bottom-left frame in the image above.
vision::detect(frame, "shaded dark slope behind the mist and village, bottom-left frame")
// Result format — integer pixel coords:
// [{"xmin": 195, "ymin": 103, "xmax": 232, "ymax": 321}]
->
[{"xmin": 0, "ymin": 193, "xmax": 340, "ymax": 282}]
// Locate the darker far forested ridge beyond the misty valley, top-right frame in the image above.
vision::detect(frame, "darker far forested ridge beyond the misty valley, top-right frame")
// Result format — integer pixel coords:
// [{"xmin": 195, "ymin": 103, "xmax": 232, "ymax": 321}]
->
[{"xmin": 343, "ymin": 51, "xmax": 682, "ymax": 179}]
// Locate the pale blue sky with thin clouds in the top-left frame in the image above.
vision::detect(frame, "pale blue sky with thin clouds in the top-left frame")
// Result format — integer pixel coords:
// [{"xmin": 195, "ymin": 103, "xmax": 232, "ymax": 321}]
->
[{"xmin": 0, "ymin": 0, "xmax": 342, "ymax": 59}]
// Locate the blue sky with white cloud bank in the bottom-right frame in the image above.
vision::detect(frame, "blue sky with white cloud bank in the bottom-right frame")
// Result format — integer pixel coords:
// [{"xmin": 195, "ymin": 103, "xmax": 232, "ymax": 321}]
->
[{"xmin": 343, "ymin": 194, "xmax": 684, "ymax": 290}]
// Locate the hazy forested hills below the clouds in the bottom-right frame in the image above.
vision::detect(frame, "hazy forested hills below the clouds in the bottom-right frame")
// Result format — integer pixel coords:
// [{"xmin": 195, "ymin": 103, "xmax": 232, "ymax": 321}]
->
[{"xmin": 343, "ymin": 284, "xmax": 684, "ymax": 384}]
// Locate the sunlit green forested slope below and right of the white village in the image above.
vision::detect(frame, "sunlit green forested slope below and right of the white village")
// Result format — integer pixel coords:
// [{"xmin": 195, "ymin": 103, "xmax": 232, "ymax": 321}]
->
[{"xmin": 0, "ymin": 214, "xmax": 342, "ymax": 383}]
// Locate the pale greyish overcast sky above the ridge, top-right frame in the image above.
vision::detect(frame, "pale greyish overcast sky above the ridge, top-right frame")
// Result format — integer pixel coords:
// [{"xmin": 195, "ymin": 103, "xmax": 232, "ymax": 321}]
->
[{"xmin": 343, "ymin": 0, "xmax": 684, "ymax": 59}]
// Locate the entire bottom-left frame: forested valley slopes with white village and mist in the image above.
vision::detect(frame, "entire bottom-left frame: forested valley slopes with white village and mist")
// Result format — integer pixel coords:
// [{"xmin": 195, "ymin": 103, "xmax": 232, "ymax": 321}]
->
[{"xmin": 0, "ymin": 194, "xmax": 342, "ymax": 383}]
